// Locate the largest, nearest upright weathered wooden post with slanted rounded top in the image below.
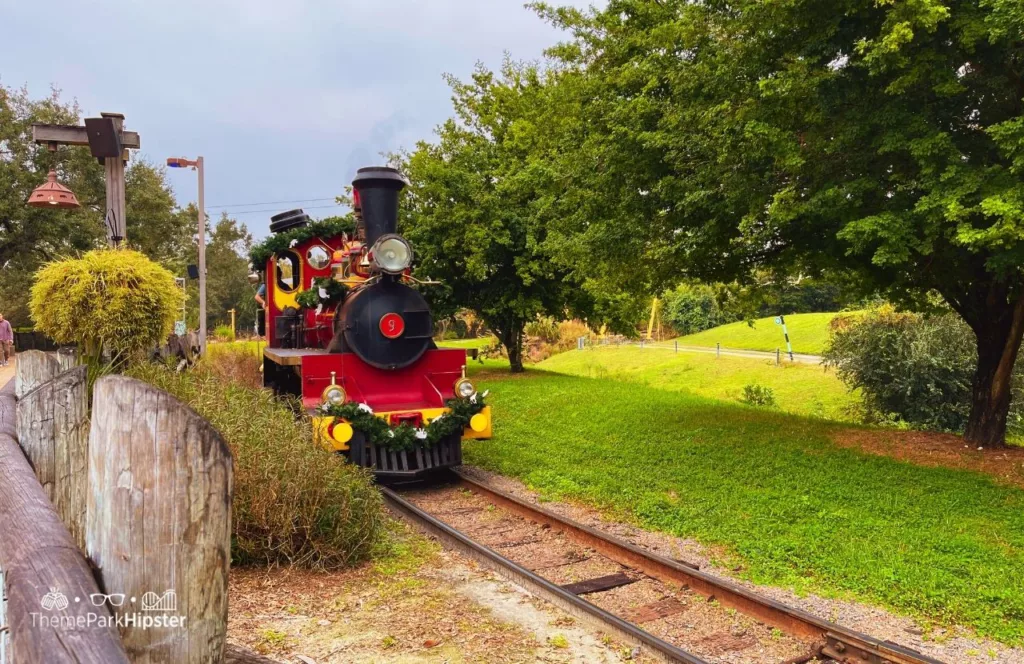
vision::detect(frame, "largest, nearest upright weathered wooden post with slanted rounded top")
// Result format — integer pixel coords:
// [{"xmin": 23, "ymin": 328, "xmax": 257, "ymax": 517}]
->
[{"xmin": 86, "ymin": 376, "xmax": 232, "ymax": 664}]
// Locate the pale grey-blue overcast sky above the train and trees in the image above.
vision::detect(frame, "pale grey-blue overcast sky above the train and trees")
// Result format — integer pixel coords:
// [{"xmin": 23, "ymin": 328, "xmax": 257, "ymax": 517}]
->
[{"xmin": 0, "ymin": 0, "xmax": 590, "ymax": 237}]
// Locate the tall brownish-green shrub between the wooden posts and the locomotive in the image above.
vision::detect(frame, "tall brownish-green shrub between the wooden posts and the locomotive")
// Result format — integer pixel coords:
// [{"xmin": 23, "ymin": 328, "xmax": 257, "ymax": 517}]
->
[{"xmin": 124, "ymin": 358, "xmax": 387, "ymax": 569}]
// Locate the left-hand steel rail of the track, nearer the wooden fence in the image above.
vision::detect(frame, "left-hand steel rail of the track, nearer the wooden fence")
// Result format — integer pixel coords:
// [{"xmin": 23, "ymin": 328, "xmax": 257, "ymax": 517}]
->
[{"xmin": 381, "ymin": 487, "xmax": 708, "ymax": 664}]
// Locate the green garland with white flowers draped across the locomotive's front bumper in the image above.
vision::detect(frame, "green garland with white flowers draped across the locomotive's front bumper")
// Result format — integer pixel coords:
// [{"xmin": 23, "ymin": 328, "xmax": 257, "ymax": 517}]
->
[{"xmin": 319, "ymin": 392, "xmax": 487, "ymax": 452}]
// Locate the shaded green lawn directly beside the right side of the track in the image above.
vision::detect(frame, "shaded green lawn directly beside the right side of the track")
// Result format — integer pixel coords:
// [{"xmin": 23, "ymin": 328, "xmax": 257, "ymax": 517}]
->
[{"xmin": 466, "ymin": 368, "xmax": 1024, "ymax": 644}]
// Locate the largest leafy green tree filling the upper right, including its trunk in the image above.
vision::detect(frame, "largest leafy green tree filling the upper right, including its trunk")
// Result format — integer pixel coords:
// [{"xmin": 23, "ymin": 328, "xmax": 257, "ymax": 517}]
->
[{"xmin": 537, "ymin": 0, "xmax": 1024, "ymax": 445}]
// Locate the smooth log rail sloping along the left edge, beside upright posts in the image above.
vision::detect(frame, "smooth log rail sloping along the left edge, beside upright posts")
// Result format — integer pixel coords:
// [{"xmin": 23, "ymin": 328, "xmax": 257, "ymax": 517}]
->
[{"xmin": 0, "ymin": 384, "xmax": 128, "ymax": 664}]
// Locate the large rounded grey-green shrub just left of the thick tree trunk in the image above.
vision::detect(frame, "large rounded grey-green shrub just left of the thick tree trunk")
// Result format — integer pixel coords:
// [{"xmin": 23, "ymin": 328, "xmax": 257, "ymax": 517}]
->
[{"xmin": 824, "ymin": 305, "xmax": 1021, "ymax": 431}]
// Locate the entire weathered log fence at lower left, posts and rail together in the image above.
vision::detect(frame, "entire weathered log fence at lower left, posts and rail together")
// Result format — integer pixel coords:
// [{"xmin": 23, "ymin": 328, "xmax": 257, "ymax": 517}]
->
[{"xmin": 0, "ymin": 350, "xmax": 234, "ymax": 664}]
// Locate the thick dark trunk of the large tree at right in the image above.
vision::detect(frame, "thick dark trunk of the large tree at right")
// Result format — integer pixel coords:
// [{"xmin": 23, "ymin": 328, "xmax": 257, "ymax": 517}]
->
[{"xmin": 964, "ymin": 297, "xmax": 1024, "ymax": 447}]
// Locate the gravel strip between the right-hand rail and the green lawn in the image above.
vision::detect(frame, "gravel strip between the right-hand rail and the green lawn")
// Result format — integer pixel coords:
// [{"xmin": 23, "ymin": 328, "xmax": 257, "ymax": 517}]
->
[{"xmin": 463, "ymin": 466, "xmax": 1024, "ymax": 664}]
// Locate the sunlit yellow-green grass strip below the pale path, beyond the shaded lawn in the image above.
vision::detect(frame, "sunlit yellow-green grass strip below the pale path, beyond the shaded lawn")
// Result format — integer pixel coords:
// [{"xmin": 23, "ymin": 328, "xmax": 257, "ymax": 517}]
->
[{"xmin": 537, "ymin": 346, "xmax": 857, "ymax": 419}]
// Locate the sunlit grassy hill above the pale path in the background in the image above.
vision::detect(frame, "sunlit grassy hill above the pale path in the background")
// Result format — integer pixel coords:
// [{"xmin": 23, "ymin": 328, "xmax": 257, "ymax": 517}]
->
[{"xmin": 679, "ymin": 314, "xmax": 860, "ymax": 355}]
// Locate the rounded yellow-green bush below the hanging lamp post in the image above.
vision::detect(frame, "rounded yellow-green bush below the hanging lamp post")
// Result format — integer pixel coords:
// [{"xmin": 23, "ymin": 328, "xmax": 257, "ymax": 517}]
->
[{"xmin": 29, "ymin": 249, "xmax": 182, "ymax": 360}]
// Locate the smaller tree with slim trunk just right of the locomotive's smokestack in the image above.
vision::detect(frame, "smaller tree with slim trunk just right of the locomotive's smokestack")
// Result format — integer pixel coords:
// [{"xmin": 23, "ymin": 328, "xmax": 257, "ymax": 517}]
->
[{"xmin": 399, "ymin": 63, "xmax": 594, "ymax": 372}]
